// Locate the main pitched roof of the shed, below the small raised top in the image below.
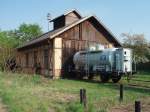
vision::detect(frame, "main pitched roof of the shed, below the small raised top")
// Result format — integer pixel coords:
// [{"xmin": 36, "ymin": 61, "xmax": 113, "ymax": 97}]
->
[{"xmin": 17, "ymin": 15, "xmax": 122, "ymax": 49}]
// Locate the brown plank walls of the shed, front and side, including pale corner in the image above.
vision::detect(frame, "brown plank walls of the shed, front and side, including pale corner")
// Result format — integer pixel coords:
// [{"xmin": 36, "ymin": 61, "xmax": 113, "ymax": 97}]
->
[{"xmin": 17, "ymin": 17, "xmax": 115, "ymax": 78}]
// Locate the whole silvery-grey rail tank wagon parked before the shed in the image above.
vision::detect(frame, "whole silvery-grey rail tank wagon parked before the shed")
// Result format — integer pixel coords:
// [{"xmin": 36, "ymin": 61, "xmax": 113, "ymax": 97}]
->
[{"xmin": 73, "ymin": 48, "xmax": 132, "ymax": 83}]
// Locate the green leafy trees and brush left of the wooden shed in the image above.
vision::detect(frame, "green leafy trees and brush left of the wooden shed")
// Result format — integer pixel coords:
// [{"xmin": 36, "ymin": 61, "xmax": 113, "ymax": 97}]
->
[{"xmin": 0, "ymin": 23, "xmax": 42, "ymax": 70}]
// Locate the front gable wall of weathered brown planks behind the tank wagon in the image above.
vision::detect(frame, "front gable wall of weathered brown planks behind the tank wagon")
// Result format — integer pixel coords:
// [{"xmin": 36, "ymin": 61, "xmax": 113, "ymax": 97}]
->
[{"xmin": 59, "ymin": 21, "xmax": 113, "ymax": 75}]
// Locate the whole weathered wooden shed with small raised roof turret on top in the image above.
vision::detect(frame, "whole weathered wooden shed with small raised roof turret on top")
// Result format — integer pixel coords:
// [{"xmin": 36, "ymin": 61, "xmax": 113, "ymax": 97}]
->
[{"xmin": 17, "ymin": 10, "xmax": 121, "ymax": 78}]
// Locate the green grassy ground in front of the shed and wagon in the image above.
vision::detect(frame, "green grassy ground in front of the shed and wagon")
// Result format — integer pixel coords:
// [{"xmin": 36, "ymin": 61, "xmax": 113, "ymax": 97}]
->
[{"xmin": 0, "ymin": 72, "xmax": 150, "ymax": 112}]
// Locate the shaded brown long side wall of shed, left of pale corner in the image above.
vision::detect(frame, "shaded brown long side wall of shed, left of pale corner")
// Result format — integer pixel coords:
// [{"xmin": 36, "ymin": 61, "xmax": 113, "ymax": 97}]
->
[{"xmin": 16, "ymin": 42, "xmax": 53, "ymax": 75}]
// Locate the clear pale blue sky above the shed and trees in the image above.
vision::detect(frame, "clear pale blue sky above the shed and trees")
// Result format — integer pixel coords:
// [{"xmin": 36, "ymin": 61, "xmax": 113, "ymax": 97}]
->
[{"xmin": 0, "ymin": 0, "xmax": 150, "ymax": 40}]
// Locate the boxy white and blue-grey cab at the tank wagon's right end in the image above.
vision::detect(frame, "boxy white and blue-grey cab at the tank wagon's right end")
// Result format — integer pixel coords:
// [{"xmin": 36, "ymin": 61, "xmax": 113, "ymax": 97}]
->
[{"xmin": 111, "ymin": 48, "xmax": 132, "ymax": 82}]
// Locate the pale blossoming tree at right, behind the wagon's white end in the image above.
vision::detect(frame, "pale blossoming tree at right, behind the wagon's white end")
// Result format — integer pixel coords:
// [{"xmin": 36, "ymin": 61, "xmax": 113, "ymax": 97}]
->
[{"xmin": 122, "ymin": 33, "xmax": 150, "ymax": 63}]
